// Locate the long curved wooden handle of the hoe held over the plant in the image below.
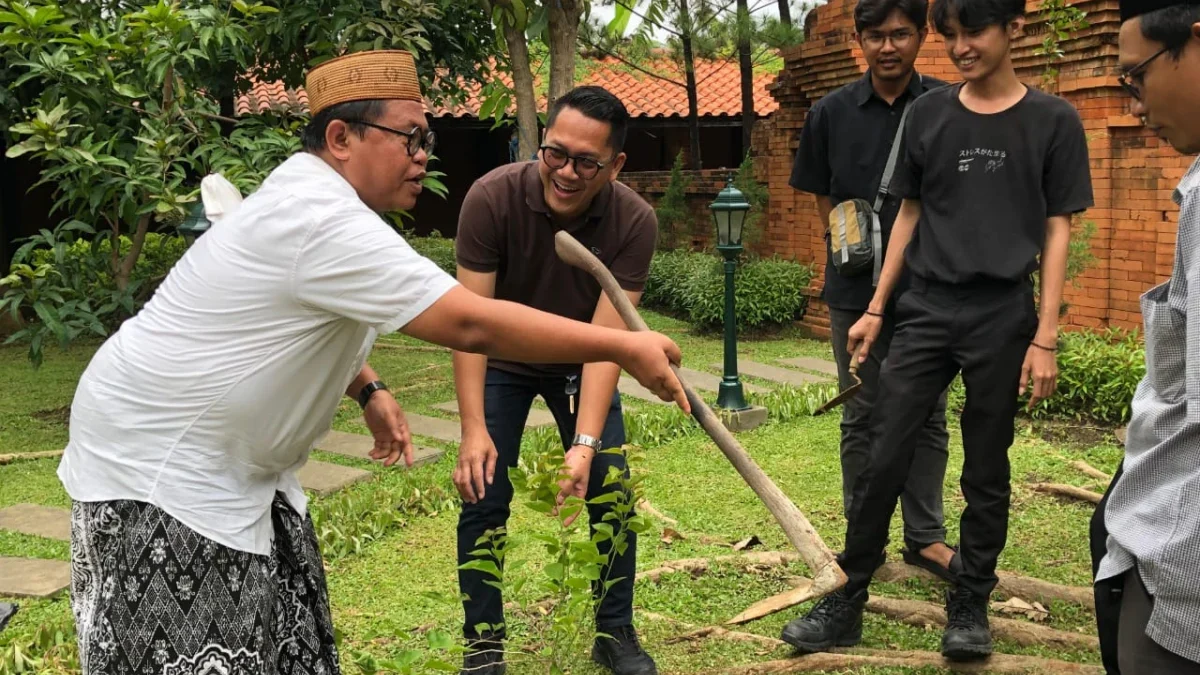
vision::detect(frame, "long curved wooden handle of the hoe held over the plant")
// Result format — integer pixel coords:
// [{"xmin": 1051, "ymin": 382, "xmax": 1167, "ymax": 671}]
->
[{"xmin": 554, "ymin": 232, "xmax": 846, "ymax": 593}]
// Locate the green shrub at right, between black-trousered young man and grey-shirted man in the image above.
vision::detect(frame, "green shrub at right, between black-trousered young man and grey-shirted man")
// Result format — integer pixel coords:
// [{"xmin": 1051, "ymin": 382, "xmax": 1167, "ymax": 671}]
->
[{"xmin": 1025, "ymin": 329, "xmax": 1146, "ymax": 424}]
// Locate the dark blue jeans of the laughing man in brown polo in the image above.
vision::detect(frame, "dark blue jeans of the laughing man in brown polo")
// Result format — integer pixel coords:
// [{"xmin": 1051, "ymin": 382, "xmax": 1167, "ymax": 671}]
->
[{"xmin": 458, "ymin": 368, "xmax": 637, "ymax": 640}]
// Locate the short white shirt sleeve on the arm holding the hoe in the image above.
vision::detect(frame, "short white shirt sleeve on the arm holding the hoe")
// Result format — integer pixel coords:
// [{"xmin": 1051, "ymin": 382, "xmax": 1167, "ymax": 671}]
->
[{"xmin": 292, "ymin": 209, "xmax": 457, "ymax": 335}]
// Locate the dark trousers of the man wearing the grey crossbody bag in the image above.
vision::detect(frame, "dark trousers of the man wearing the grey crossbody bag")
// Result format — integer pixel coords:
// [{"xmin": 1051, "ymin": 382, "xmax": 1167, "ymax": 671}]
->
[{"xmin": 829, "ymin": 307, "xmax": 950, "ymax": 550}]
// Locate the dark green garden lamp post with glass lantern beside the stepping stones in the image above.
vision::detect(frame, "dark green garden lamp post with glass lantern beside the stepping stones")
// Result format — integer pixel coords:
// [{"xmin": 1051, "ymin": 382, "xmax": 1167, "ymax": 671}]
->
[{"xmin": 709, "ymin": 175, "xmax": 750, "ymax": 411}]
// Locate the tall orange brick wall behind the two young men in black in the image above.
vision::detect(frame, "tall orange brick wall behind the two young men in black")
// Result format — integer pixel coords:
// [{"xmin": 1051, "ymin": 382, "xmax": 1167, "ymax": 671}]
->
[{"xmin": 755, "ymin": 0, "xmax": 1190, "ymax": 335}]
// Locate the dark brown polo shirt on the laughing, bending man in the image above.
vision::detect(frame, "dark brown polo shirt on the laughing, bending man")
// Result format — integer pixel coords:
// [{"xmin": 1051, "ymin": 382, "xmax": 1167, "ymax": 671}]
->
[{"xmin": 455, "ymin": 160, "xmax": 659, "ymax": 376}]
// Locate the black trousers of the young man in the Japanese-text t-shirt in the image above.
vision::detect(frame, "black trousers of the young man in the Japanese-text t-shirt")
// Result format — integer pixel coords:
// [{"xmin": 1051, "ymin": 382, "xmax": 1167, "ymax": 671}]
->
[{"xmin": 842, "ymin": 279, "xmax": 1038, "ymax": 597}]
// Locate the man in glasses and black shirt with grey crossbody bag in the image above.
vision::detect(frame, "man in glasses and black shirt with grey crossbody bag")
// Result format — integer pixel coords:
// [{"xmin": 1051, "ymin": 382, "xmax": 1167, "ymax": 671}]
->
[{"xmin": 791, "ymin": 0, "xmax": 959, "ymax": 580}]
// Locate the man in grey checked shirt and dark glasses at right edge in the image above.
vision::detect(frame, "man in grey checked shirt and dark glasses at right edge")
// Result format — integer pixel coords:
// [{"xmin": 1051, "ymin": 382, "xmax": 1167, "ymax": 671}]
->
[{"xmin": 1096, "ymin": 0, "xmax": 1200, "ymax": 675}]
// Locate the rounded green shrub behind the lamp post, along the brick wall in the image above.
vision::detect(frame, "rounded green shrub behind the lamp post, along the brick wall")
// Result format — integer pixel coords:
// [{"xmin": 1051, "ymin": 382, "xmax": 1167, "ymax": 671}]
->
[{"xmin": 685, "ymin": 258, "xmax": 812, "ymax": 330}]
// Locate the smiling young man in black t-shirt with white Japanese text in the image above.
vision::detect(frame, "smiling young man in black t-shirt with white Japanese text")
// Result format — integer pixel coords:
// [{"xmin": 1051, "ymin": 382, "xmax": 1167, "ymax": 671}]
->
[{"xmin": 784, "ymin": 0, "xmax": 1093, "ymax": 659}]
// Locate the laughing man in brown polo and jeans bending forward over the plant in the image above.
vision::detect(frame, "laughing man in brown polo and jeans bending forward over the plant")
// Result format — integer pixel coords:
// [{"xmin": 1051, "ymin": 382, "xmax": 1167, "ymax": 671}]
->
[{"xmin": 454, "ymin": 86, "xmax": 658, "ymax": 675}]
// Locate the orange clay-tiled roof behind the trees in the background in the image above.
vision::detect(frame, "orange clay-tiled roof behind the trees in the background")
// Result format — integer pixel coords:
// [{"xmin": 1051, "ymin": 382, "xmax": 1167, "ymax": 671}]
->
[{"xmin": 236, "ymin": 58, "xmax": 779, "ymax": 118}]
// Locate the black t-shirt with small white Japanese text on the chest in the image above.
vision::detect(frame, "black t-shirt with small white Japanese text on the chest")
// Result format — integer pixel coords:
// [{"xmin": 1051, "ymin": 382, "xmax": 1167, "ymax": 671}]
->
[{"xmin": 890, "ymin": 84, "xmax": 1093, "ymax": 283}]
